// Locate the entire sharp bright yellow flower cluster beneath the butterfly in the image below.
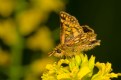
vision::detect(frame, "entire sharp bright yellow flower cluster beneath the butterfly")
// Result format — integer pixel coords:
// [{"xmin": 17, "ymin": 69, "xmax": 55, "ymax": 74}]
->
[{"xmin": 42, "ymin": 54, "xmax": 120, "ymax": 80}]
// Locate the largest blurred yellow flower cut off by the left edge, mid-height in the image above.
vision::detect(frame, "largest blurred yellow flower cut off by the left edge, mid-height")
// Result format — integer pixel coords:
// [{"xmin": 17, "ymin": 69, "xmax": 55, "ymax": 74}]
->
[{"xmin": 0, "ymin": 19, "xmax": 18, "ymax": 45}]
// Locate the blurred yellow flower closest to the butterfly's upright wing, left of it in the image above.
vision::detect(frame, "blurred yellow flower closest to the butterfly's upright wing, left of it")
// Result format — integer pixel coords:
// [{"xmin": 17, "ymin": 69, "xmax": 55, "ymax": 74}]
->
[{"xmin": 27, "ymin": 26, "xmax": 54, "ymax": 53}]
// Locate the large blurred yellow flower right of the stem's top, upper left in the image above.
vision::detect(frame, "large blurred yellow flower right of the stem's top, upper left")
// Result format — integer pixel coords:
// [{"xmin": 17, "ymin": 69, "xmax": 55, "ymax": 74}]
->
[{"xmin": 17, "ymin": 9, "xmax": 46, "ymax": 35}]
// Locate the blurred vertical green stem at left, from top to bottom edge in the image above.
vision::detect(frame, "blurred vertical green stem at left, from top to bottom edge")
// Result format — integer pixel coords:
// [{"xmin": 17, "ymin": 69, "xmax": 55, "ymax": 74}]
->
[{"xmin": 9, "ymin": 0, "xmax": 26, "ymax": 80}]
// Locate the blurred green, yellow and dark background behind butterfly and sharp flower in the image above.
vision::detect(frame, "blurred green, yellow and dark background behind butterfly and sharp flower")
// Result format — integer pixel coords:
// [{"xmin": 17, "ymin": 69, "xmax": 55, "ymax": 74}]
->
[{"xmin": 0, "ymin": 0, "xmax": 121, "ymax": 80}]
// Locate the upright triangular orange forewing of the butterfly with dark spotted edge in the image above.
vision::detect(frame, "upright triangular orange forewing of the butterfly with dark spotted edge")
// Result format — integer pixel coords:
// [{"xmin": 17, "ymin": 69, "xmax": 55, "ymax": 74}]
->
[{"xmin": 60, "ymin": 11, "xmax": 83, "ymax": 45}]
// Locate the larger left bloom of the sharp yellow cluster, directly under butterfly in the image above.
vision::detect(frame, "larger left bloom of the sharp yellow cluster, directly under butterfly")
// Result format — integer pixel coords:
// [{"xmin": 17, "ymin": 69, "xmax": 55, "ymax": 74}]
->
[{"xmin": 42, "ymin": 54, "xmax": 95, "ymax": 80}]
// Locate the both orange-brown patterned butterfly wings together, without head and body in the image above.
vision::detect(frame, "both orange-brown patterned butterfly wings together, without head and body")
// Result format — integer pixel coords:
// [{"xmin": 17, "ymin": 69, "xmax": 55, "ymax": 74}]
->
[{"xmin": 60, "ymin": 12, "xmax": 100, "ymax": 51}]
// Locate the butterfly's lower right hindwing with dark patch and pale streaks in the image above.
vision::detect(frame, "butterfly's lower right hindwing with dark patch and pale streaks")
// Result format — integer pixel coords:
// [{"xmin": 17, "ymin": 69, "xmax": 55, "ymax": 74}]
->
[{"xmin": 68, "ymin": 25, "xmax": 100, "ymax": 51}]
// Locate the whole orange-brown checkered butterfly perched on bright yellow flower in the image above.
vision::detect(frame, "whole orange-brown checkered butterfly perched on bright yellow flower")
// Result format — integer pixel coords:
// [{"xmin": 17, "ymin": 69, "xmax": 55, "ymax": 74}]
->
[{"xmin": 49, "ymin": 11, "xmax": 100, "ymax": 57}]
